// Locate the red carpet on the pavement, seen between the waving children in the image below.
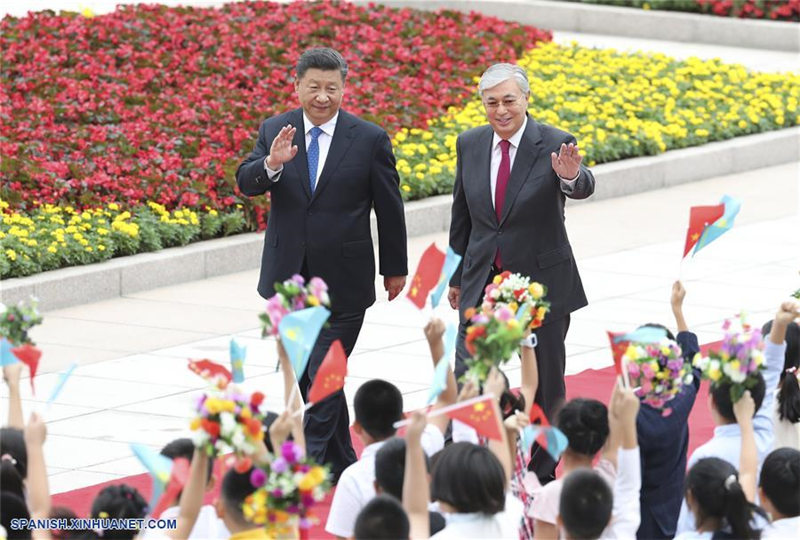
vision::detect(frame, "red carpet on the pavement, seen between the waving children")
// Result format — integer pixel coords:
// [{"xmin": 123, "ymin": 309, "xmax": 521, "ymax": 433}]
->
[{"xmin": 53, "ymin": 343, "xmax": 718, "ymax": 538}]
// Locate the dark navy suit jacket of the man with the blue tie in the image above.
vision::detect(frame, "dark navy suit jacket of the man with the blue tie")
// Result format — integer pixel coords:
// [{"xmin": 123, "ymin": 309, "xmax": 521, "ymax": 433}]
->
[{"xmin": 236, "ymin": 109, "xmax": 408, "ymax": 312}]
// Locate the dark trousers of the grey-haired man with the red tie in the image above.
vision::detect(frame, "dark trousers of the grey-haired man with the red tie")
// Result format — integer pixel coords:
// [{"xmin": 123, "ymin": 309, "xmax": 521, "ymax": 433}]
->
[{"xmin": 455, "ymin": 267, "xmax": 570, "ymax": 485}]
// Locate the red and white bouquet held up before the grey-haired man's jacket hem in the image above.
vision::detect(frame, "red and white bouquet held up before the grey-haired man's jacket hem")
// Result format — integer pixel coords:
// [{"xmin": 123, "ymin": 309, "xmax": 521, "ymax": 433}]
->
[{"xmin": 482, "ymin": 271, "xmax": 550, "ymax": 329}]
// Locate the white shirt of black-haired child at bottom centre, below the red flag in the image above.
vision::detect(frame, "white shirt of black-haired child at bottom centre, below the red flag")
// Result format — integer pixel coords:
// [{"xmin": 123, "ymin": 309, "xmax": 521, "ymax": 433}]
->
[{"xmin": 431, "ymin": 493, "xmax": 524, "ymax": 540}]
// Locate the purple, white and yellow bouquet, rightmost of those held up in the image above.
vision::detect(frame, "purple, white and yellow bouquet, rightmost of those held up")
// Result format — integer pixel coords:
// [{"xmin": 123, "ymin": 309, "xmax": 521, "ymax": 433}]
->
[{"xmin": 694, "ymin": 319, "xmax": 764, "ymax": 403}]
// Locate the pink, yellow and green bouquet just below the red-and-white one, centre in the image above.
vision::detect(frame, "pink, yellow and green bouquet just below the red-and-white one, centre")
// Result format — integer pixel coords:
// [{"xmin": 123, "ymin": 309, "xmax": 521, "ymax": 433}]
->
[{"xmin": 464, "ymin": 304, "xmax": 525, "ymax": 384}]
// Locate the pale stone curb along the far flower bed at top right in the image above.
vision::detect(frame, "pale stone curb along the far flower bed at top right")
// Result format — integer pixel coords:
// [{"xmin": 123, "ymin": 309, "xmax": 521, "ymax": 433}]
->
[{"xmin": 351, "ymin": 0, "xmax": 800, "ymax": 52}]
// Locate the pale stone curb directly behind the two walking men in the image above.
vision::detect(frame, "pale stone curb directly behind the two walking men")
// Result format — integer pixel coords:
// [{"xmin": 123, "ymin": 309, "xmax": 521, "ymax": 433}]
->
[{"xmin": 0, "ymin": 127, "xmax": 800, "ymax": 311}]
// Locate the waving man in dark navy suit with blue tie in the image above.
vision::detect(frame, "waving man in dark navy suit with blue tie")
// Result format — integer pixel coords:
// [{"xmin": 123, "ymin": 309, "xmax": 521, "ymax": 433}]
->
[{"xmin": 231, "ymin": 49, "xmax": 408, "ymax": 479}]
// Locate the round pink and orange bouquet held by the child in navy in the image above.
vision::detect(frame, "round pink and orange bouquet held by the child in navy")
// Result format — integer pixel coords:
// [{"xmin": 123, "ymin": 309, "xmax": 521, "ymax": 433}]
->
[{"xmin": 624, "ymin": 338, "xmax": 693, "ymax": 416}]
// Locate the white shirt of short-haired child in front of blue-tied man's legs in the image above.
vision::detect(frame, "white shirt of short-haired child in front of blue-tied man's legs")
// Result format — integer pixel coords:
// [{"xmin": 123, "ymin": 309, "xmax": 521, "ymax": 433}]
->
[{"xmin": 325, "ymin": 424, "xmax": 444, "ymax": 538}]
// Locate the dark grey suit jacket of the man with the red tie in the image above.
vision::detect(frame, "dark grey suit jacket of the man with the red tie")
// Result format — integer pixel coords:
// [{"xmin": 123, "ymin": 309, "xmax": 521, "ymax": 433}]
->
[{"xmin": 450, "ymin": 116, "xmax": 594, "ymax": 322}]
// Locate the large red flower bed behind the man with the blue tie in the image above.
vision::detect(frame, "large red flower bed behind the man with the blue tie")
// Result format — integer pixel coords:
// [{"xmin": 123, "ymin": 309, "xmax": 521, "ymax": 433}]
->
[{"xmin": 0, "ymin": 2, "xmax": 551, "ymax": 225}]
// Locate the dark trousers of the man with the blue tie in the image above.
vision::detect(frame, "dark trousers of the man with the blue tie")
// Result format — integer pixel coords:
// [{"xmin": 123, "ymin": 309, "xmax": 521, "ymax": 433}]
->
[{"xmin": 299, "ymin": 311, "xmax": 364, "ymax": 480}]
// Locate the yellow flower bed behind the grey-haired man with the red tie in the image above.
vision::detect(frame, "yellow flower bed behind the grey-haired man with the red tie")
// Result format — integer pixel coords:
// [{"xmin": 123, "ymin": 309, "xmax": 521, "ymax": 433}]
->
[{"xmin": 393, "ymin": 43, "xmax": 800, "ymax": 199}]
